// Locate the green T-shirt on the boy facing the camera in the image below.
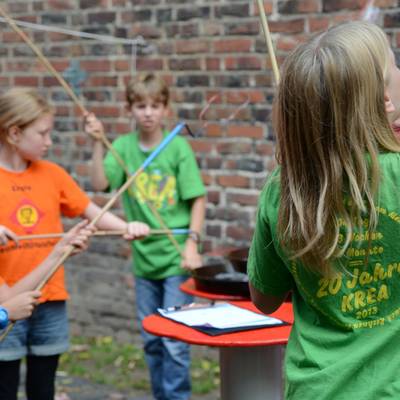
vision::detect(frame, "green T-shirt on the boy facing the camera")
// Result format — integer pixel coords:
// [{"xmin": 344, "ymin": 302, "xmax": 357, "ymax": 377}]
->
[{"xmin": 104, "ymin": 132, "xmax": 205, "ymax": 279}]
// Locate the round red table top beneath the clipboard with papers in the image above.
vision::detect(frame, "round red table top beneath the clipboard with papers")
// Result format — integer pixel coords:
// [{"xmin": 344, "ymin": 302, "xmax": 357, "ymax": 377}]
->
[{"xmin": 143, "ymin": 301, "xmax": 293, "ymax": 347}]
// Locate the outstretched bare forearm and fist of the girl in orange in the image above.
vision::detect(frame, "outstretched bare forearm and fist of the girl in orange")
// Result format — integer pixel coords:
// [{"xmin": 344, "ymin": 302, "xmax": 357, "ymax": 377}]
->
[{"xmin": 84, "ymin": 202, "xmax": 150, "ymax": 240}]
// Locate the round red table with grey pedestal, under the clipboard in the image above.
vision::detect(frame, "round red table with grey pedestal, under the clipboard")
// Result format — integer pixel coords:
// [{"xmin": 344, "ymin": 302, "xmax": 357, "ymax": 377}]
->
[{"xmin": 143, "ymin": 297, "xmax": 293, "ymax": 400}]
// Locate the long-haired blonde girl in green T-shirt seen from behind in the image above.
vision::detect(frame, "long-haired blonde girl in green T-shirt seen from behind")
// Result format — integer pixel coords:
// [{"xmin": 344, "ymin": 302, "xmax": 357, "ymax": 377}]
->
[{"xmin": 248, "ymin": 22, "xmax": 400, "ymax": 400}]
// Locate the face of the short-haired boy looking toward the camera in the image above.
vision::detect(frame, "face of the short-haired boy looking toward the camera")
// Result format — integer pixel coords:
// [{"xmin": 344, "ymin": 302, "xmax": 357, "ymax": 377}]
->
[{"xmin": 130, "ymin": 97, "xmax": 167, "ymax": 134}]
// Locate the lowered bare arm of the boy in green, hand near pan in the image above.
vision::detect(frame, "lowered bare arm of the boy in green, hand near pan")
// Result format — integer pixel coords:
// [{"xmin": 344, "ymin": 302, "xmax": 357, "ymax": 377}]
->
[{"xmin": 182, "ymin": 196, "xmax": 206, "ymax": 269}]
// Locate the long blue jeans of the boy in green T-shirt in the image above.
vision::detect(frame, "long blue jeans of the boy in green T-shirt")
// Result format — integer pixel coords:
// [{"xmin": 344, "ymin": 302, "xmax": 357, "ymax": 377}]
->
[{"xmin": 135, "ymin": 276, "xmax": 193, "ymax": 400}]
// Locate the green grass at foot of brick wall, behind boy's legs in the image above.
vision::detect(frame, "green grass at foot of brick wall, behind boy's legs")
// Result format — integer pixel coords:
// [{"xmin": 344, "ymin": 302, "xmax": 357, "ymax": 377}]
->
[{"xmin": 59, "ymin": 336, "xmax": 219, "ymax": 394}]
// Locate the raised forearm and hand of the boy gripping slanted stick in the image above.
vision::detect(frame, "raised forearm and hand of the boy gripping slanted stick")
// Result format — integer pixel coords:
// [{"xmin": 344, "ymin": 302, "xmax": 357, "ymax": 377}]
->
[{"xmin": 84, "ymin": 113, "xmax": 109, "ymax": 190}]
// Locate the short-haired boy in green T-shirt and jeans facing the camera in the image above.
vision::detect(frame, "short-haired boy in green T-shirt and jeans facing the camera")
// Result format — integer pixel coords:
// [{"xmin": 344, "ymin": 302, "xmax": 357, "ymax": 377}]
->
[{"xmin": 86, "ymin": 73, "xmax": 205, "ymax": 400}]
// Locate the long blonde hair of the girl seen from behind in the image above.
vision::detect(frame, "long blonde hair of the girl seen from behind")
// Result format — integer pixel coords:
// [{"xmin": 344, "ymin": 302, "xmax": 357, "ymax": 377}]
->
[{"xmin": 274, "ymin": 22, "xmax": 400, "ymax": 275}]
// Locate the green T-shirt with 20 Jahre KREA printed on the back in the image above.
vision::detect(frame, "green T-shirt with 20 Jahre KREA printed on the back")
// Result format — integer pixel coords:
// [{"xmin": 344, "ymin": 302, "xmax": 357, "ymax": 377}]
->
[{"xmin": 248, "ymin": 153, "xmax": 400, "ymax": 400}]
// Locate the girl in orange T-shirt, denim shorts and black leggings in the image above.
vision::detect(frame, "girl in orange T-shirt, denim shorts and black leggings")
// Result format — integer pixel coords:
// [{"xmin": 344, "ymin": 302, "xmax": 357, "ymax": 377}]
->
[{"xmin": 0, "ymin": 88, "xmax": 149, "ymax": 400}]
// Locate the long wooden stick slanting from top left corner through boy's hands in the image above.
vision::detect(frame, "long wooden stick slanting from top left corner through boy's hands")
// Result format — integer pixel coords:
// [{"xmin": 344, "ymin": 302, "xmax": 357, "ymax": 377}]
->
[{"xmin": 0, "ymin": 7, "xmax": 182, "ymax": 256}]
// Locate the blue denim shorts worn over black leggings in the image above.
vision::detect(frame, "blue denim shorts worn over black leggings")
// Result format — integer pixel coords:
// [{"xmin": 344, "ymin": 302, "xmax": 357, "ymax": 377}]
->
[{"xmin": 0, "ymin": 301, "xmax": 69, "ymax": 361}]
